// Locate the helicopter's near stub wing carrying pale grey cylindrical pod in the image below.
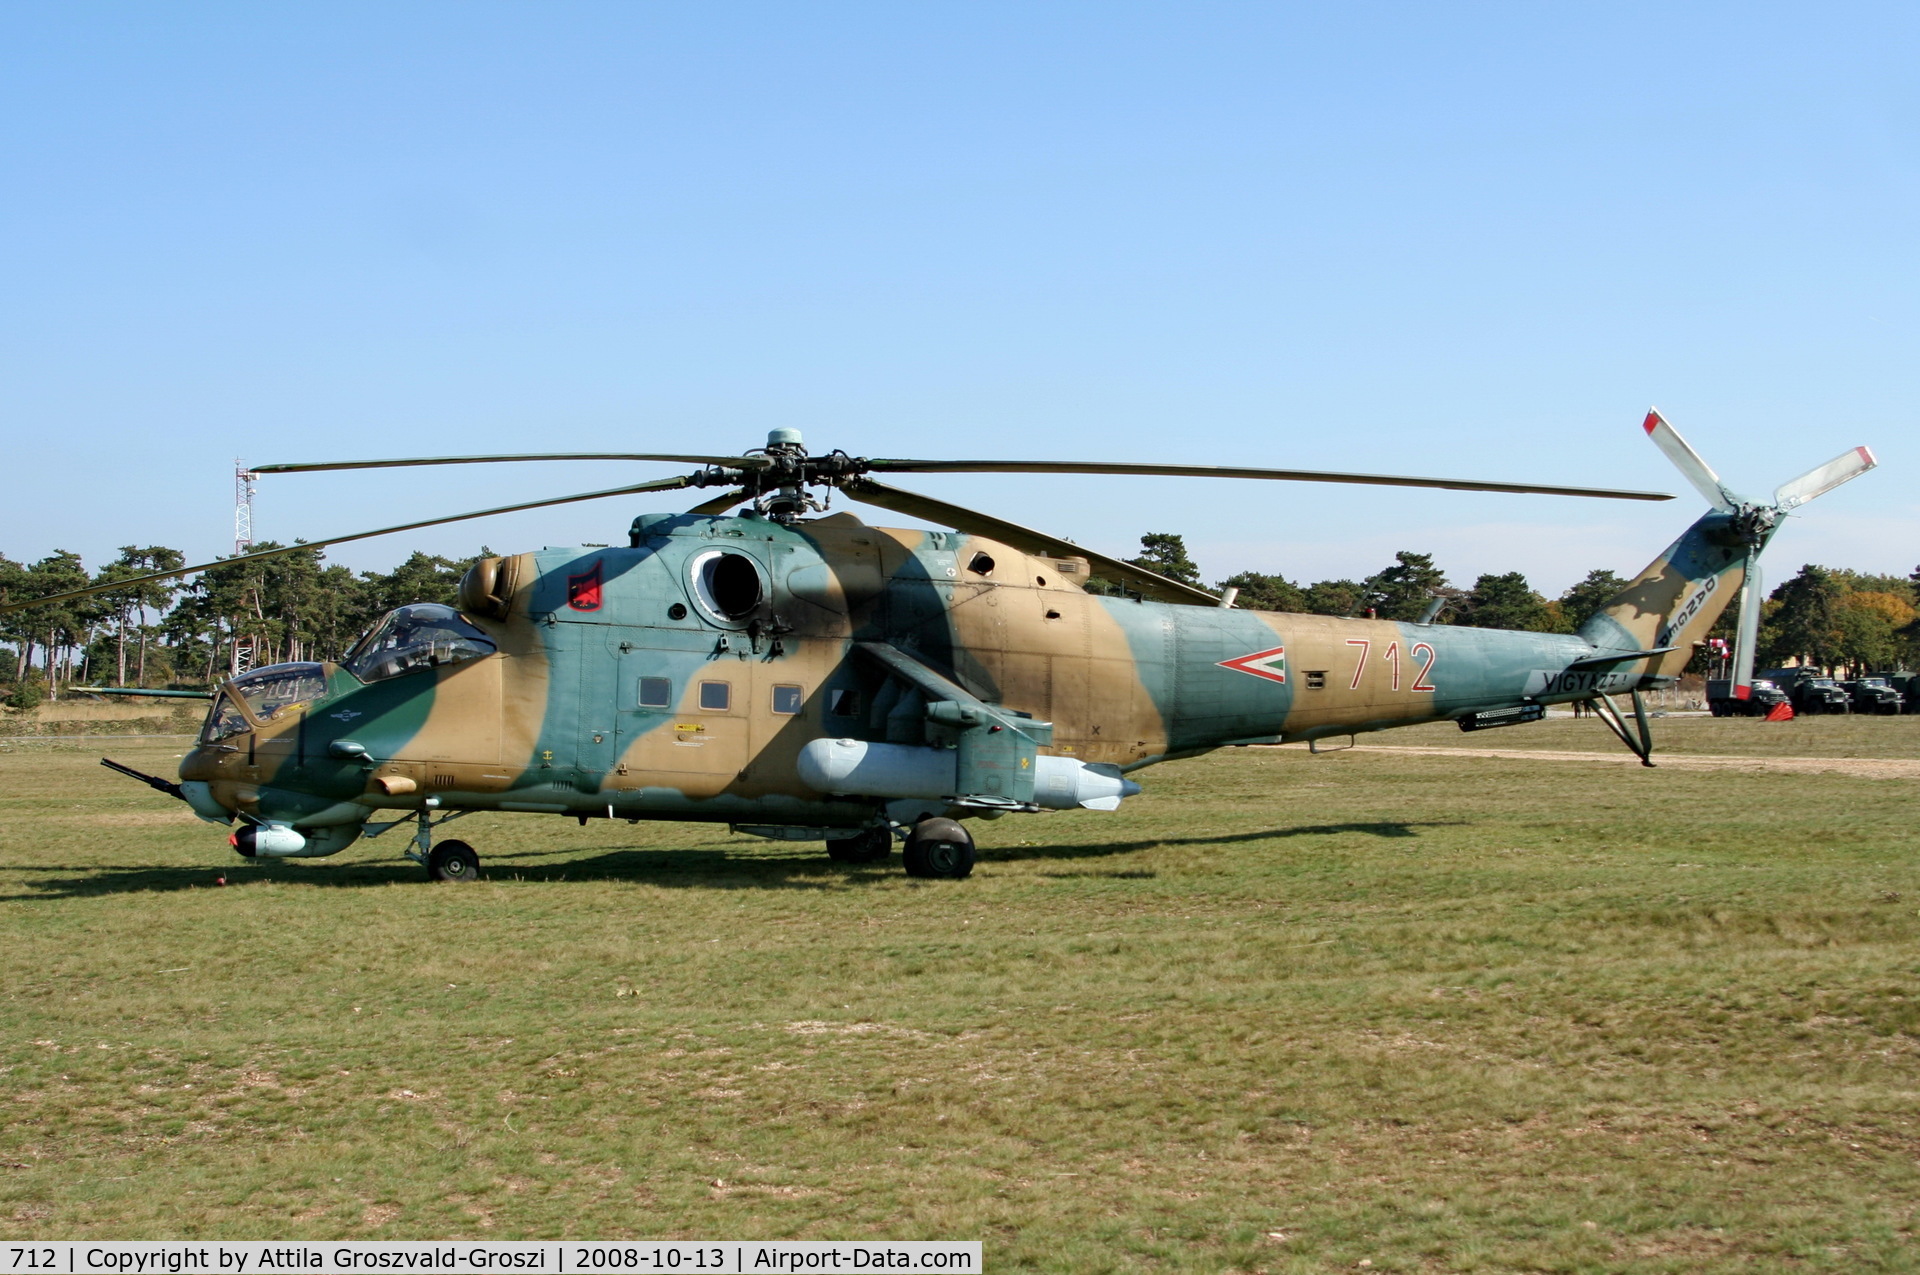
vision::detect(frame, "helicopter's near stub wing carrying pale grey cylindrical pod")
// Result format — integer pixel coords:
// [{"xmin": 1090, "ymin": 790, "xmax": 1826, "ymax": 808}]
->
[{"xmin": 799, "ymin": 641, "xmax": 1140, "ymax": 810}]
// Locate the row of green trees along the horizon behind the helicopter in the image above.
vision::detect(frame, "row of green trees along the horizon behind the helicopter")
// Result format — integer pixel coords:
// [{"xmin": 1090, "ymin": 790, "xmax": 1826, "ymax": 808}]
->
[{"xmin": 0, "ymin": 532, "xmax": 1920, "ymax": 709}]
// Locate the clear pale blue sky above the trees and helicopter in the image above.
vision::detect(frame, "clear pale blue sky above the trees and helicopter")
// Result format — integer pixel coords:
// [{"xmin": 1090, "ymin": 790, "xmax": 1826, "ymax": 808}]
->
[{"xmin": 0, "ymin": 2, "xmax": 1920, "ymax": 591}]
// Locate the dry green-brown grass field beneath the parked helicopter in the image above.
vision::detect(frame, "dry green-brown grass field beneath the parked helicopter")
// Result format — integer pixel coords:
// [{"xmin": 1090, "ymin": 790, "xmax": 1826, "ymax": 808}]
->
[{"xmin": 0, "ymin": 718, "xmax": 1920, "ymax": 1271}]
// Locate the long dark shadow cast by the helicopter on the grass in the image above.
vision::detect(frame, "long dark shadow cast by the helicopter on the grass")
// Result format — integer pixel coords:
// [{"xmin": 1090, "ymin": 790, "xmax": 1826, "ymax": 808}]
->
[{"xmin": 0, "ymin": 820, "xmax": 1459, "ymax": 894}]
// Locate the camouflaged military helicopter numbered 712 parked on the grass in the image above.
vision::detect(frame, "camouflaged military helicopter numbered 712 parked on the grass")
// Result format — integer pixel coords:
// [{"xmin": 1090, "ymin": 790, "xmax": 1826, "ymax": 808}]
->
[{"xmin": 18, "ymin": 413, "xmax": 1876, "ymax": 879}]
